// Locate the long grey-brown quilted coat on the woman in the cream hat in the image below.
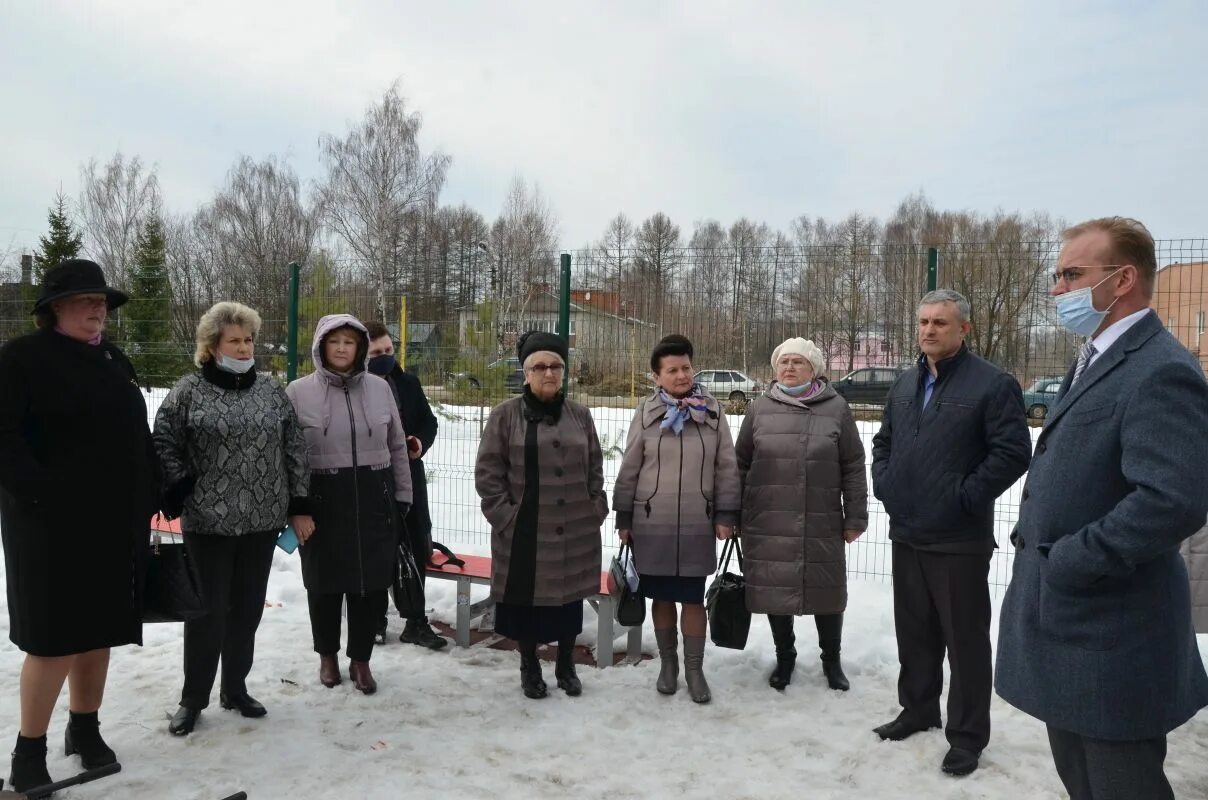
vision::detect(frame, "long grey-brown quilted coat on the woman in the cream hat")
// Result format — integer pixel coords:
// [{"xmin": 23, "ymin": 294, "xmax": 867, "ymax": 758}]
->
[{"xmin": 736, "ymin": 383, "xmax": 869, "ymax": 614}]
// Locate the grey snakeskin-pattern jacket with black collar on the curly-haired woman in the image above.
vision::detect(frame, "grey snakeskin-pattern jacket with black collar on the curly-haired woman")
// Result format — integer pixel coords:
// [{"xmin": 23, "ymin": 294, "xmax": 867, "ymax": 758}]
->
[{"xmin": 152, "ymin": 361, "xmax": 310, "ymax": 537}]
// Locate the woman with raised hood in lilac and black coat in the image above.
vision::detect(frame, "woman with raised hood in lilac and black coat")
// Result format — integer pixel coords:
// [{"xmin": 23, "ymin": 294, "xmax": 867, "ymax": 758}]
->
[{"xmin": 285, "ymin": 314, "xmax": 411, "ymax": 695}]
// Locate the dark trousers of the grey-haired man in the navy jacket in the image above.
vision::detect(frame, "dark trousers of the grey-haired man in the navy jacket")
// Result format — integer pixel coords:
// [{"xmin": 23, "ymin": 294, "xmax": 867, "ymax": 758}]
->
[{"xmin": 893, "ymin": 543, "xmax": 993, "ymax": 753}]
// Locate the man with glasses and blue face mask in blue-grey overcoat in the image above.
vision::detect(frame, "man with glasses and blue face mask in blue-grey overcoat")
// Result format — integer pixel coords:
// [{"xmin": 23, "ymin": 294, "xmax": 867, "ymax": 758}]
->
[{"xmin": 995, "ymin": 218, "xmax": 1208, "ymax": 800}]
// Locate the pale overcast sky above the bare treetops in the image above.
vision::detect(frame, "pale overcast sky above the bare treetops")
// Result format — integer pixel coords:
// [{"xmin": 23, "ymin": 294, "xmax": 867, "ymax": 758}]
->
[{"xmin": 0, "ymin": 0, "xmax": 1208, "ymax": 253}]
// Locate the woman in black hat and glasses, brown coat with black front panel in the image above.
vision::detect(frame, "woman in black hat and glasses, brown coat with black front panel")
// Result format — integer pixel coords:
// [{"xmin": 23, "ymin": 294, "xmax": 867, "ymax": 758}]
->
[{"xmin": 474, "ymin": 331, "xmax": 608, "ymax": 700}]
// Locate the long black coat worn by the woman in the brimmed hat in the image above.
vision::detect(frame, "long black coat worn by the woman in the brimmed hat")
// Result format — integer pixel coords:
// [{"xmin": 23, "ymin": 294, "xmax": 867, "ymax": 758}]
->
[{"xmin": 0, "ymin": 330, "xmax": 158, "ymax": 656}]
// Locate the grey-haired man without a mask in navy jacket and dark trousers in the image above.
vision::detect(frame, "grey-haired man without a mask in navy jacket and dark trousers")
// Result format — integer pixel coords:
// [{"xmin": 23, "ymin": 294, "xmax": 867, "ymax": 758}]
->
[{"xmin": 872, "ymin": 289, "xmax": 1032, "ymax": 775}]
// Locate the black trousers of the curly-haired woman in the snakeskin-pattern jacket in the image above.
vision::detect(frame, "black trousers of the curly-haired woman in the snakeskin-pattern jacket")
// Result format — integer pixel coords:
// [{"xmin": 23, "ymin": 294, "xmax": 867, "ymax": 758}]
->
[{"xmin": 180, "ymin": 531, "xmax": 278, "ymax": 711}]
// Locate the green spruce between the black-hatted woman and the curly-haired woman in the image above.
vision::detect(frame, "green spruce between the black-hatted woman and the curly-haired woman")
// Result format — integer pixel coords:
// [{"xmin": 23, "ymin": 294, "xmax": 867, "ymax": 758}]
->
[{"xmin": 121, "ymin": 214, "xmax": 188, "ymax": 388}]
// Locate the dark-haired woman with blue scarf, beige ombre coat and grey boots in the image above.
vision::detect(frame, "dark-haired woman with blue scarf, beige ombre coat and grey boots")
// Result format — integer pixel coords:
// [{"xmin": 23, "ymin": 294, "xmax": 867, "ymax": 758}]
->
[{"xmin": 612, "ymin": 334, "xmax": 739, "ymax": 703}]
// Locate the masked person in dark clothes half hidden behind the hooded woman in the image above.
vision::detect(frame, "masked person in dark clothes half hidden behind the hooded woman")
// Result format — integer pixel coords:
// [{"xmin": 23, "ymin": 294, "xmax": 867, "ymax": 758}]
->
[{"xmin": 365, "ymin": 320, "xmax": 448, "ymax": 650}]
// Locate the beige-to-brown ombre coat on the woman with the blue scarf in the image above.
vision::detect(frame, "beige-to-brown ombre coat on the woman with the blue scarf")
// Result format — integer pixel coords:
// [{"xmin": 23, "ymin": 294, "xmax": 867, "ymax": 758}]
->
[{"xmin": 612, "ymin": 395, "xmax": 739, "ymax": 578}]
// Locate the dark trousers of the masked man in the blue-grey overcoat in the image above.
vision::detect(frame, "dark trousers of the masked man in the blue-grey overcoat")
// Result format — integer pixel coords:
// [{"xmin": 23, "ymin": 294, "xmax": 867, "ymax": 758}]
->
[{"xmin": 1049, "ymin": 726, "xmax": 1174, "ymax": 800}]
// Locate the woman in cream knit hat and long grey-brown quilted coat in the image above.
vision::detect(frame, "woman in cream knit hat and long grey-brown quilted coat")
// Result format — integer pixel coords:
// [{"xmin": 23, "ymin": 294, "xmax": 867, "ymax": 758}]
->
[{"xmin": 736, "ymin": 338, "xmax": 869, "ymax": 691}]
